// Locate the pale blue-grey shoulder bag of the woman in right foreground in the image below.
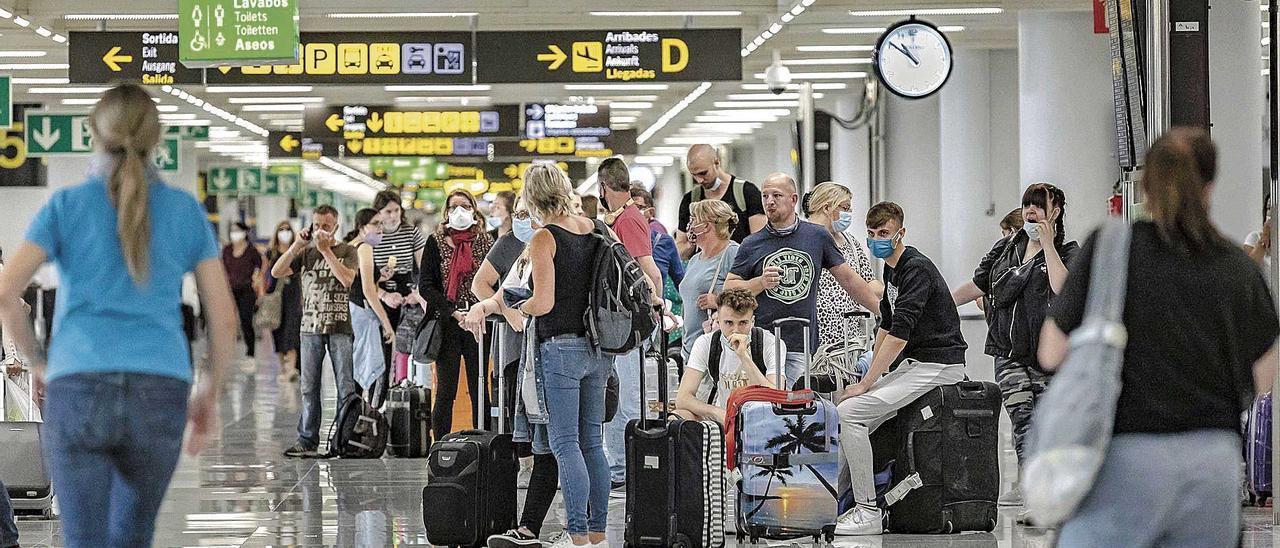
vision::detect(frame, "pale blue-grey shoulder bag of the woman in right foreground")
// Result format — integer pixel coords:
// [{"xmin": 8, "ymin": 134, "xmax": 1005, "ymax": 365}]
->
[{"xmin": 1023, "ymin": 220, "xmax": 1130, "ymax": 528}]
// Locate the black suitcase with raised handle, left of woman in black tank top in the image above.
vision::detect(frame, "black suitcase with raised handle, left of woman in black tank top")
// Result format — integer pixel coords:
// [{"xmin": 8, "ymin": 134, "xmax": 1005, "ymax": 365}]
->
[{"xmin": 422, "ymin": 318, "xmax": 517, "ymax": 547}]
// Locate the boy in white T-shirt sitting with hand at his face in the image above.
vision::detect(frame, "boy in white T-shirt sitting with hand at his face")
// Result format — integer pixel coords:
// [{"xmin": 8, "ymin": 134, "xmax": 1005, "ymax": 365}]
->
[{"xmin": 676, "ymin": 289, "xmax": 787, "ymax": 426}]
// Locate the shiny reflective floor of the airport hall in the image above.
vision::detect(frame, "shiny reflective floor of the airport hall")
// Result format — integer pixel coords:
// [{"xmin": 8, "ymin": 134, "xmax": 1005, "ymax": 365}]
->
[{"xmin": 10, "ymin": 340, "xmax": 1275, "ymax": 548}]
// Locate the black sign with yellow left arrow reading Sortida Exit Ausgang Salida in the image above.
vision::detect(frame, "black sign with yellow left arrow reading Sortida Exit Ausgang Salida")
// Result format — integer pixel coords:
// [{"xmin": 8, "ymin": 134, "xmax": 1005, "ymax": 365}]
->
[{"xmin": 68, "ymin": 32, "xmax": 205, "ymax": 86}]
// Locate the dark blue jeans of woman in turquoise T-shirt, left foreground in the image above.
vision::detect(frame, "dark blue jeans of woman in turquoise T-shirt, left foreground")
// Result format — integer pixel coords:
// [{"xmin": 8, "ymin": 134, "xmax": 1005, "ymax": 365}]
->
[{"xmin": 44, "ymin": 373, "xmax": 191, "ymax": 547}]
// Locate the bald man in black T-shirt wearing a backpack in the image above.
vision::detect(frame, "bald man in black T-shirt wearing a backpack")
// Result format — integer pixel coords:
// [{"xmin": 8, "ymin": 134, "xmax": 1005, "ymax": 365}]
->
[{"xmin": 676, "ymin": 145, "xmax": 768, "ymax": 260}]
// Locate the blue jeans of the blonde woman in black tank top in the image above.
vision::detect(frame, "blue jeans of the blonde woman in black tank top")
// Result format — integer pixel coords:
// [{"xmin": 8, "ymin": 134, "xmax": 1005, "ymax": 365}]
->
[{"xmin": 539, "ymin": 335, "xmax": 612, "ymax": 535}]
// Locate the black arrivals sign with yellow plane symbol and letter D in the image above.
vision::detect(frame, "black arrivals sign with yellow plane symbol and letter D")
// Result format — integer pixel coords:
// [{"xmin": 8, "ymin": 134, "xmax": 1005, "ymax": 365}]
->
[{"xmin": 476, "ymin": 28, "xmax": 742, "ymax": 83}]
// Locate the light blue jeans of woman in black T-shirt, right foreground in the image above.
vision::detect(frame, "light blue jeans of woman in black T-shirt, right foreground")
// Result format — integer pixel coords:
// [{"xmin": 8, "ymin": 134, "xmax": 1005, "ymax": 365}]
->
[{"xmin": 1057, "ymin": 430, "xmax": 1242, "ymax": 548}]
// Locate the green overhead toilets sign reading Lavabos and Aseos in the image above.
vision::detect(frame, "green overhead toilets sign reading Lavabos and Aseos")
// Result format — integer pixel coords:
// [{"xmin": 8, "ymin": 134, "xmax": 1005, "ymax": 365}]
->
[{"xmin": 178, "ymin": 0, "xmax": 301, "ymax": 68}]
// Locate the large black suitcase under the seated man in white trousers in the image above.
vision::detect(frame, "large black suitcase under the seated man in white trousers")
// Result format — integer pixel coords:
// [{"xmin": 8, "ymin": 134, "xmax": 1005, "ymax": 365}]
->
[{"xmin": 888, "ymin": 380, "xmax": 1001, "ymax": 534}]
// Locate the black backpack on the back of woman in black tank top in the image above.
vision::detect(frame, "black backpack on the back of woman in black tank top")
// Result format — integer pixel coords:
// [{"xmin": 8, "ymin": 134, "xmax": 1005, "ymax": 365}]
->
[{"xmin": 584, "ymin": 220, "xmax": 658, "ymax": 356}]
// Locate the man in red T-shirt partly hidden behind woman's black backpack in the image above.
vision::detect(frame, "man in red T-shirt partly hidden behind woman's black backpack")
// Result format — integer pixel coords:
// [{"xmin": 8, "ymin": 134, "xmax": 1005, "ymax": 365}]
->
[{"xmin": 596, "ymin": 157, "xmax": 662, "ymax": 498}]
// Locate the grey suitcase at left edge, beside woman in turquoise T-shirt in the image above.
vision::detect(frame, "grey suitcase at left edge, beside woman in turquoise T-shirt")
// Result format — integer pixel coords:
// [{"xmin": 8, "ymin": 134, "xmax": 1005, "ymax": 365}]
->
[{"xmin": 0, "ymin": 366, "xmax": 54, "ymax": 517}]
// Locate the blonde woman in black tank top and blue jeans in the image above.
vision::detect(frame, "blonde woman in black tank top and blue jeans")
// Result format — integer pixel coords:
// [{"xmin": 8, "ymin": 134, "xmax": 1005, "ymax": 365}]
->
[{"xmin": 520, "ymin": 164, "xmax": 613, "ymax": 547}]
